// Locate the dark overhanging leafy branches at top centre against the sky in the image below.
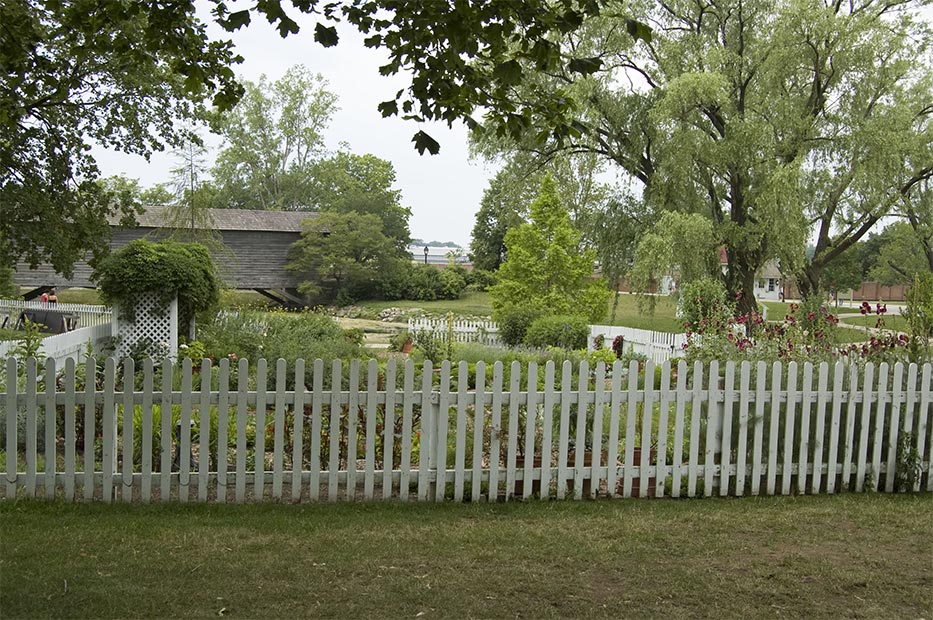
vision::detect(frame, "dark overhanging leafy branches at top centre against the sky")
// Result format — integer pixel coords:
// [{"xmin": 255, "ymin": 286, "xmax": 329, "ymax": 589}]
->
[{"xmin": 212, "ymin": 0, "xmax": 650, "ymax": 154}]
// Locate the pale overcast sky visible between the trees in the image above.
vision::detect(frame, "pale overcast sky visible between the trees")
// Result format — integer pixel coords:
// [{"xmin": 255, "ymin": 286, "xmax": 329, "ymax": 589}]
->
[{"xmin": 95, "ymin": 9, "xmax": 494, "ymax": 247}]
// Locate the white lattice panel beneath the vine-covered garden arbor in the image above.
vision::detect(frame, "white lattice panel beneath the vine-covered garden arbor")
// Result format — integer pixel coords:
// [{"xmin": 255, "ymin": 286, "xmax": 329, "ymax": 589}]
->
[{"xmin": 113, "ymin": 293, "xmax": 178, "ymax": 359}]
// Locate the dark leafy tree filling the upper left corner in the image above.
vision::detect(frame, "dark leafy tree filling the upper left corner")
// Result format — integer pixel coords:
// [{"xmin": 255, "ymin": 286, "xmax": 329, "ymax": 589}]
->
[{"xmin": 0, "ymin": 0, "xmax": 240, "ymax": 275}]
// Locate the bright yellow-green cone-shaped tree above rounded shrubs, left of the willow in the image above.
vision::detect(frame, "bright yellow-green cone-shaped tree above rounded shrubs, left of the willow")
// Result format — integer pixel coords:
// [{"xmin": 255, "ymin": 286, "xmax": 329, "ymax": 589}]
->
[{"xmin": 489, "ymin": 175, "xmax": 609, "ymax": 321}]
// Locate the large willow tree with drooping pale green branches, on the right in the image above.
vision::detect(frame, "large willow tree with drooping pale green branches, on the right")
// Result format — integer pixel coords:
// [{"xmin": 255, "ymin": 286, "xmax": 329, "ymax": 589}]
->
[{"xmin": 476, "ymin": 0, "xmax": 933, "ymax": 313}]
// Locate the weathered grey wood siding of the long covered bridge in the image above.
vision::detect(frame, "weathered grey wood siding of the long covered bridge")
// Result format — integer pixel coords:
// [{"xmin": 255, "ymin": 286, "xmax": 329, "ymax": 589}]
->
[{"xmin": 14, "ymin": 228, "xmax": 300, "ymax": 289}]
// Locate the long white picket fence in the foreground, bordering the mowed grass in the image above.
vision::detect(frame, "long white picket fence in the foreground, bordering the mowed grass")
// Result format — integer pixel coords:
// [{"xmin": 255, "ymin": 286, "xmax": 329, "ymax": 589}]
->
[{"xmin": 0, "ymin": 358, "xmax": 933, "ymax": 502}]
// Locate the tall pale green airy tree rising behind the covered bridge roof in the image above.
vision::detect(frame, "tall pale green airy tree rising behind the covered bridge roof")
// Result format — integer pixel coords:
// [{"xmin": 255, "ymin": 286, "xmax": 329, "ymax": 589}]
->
[{"xmin": 213, "ymin": 65, "xmax": 337, "ymax": 210}]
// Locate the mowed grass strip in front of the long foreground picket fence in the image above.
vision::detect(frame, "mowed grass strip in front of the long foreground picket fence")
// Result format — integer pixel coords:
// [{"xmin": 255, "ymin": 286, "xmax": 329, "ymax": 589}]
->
[{"xmin": 0, "ymin": 494, "xmax": 933, "ymax": 619}]
